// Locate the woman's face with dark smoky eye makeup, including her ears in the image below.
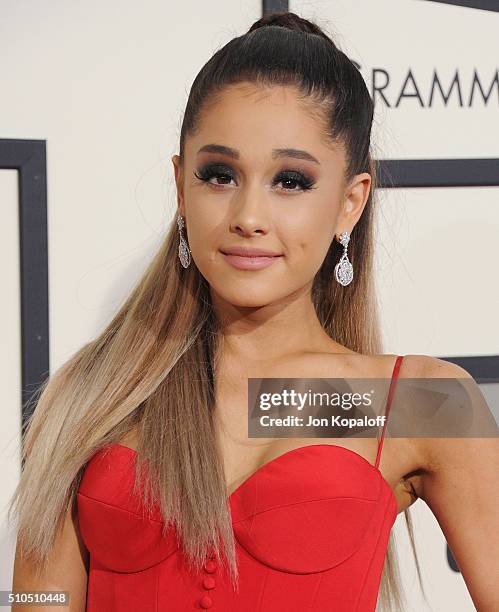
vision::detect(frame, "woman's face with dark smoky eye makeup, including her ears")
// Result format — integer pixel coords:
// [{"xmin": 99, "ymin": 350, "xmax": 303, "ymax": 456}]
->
[{"xmin": 172, "ymin": 83, "xmax": 370, "ymax": 307}]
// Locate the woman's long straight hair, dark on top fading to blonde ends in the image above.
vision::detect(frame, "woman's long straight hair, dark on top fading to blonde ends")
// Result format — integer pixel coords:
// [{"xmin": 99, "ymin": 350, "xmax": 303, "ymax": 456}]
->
[{"xmin": 9, "ymin": 13, "xmax": 426, "ymax": 609}]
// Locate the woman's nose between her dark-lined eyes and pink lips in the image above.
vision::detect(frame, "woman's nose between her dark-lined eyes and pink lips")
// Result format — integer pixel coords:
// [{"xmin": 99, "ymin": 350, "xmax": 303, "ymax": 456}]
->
[{"xmin": 230, "ymin": 187, "xmax": 270, "ymax": 236}]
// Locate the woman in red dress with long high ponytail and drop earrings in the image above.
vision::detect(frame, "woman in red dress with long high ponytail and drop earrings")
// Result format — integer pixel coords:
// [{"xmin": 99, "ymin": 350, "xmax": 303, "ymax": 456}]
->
[{"xmin": 9, "ymin": 13, "xmax": 499, "ymax": 612}]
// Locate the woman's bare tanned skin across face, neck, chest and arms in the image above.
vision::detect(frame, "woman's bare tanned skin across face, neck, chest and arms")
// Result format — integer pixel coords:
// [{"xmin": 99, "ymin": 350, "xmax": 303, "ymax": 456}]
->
[{"xmin": 12, "ymin": 84, "xmax": 499, "ymax": 612}]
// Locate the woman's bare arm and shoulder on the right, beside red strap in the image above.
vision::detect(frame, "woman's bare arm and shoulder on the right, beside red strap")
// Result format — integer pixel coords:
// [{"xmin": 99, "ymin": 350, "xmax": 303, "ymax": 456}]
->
[{"xmin": 420, "ymin": 357, "xmax": 499, "ymax": 612}]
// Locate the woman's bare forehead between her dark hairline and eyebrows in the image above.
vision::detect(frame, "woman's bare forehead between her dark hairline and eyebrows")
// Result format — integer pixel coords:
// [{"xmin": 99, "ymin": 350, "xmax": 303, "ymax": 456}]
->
[{"xmin": 185, "ymin": 82, "xmax": 345, "ymax": 168}]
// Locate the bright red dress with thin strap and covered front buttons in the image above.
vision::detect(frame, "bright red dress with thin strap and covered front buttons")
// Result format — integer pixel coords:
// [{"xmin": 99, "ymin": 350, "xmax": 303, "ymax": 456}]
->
[{"xmin": 77, "ymin": 356, "xmax": 402, "ymax": 612}]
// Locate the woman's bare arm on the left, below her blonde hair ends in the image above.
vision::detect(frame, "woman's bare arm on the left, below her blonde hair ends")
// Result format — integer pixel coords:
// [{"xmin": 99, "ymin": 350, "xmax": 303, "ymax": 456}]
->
[{"xmin": 12, "ymin": 502, "xmax": 88, "ymax": 612}]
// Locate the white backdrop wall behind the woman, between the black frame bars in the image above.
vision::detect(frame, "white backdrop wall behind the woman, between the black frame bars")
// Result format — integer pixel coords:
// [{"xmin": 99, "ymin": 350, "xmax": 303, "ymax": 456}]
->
[{"xmin": 0, "ymin": 0, "xmax": 499, "ymax": 612}]
